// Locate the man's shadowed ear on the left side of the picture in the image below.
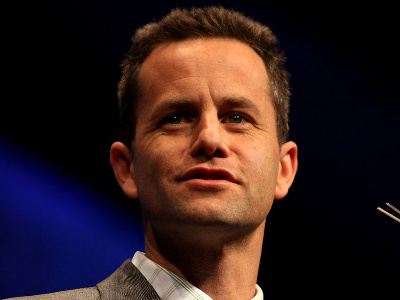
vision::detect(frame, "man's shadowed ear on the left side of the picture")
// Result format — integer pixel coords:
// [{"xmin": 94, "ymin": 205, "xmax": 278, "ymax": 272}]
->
[{"xmin": 110, "ymin": 142, "xmax": 139, "ymax": 199}]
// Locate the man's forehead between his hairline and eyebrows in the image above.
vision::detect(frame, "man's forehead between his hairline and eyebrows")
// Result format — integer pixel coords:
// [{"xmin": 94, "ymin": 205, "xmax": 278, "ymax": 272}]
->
[{"xmin": 139, "ymin": 38, "xmax": 268, "ymax": 99}]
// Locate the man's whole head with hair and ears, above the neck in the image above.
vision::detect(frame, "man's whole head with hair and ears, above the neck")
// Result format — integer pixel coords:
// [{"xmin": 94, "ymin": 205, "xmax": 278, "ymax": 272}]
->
[{"xmin": 110, "ymin": 8, "xmax": 297, "ymax": 240}]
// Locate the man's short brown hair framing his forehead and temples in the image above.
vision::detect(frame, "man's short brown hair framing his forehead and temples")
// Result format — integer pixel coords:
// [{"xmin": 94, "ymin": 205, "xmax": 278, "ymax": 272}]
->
[{"xmin": 118, "ymin": 7, "xmax": 290, "ymax": 148}]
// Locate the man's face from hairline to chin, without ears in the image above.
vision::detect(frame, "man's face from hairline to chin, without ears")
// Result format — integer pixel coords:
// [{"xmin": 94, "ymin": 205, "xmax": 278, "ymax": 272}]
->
[{"xmin": 132, "ymin": 39, "xmax": 280, "ymax": 233}]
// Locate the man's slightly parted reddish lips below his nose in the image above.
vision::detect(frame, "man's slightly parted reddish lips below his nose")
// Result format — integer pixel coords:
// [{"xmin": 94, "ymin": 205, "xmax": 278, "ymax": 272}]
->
[{"xmin": 179, "ymin": 167, "xmax": 237, "ymax": 183}]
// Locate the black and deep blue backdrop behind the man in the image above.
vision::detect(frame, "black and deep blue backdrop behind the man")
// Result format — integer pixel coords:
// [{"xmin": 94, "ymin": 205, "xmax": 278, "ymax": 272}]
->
[{"xmin": 0, "ymin": 0, "xmax": 400, "ymax": 299}]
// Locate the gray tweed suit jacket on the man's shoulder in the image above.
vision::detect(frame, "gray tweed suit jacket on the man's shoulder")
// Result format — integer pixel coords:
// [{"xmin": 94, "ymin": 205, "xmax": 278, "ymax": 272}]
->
[{"xmin": 4, "ymin": 259, "xmax": 160, "ymax": 300}]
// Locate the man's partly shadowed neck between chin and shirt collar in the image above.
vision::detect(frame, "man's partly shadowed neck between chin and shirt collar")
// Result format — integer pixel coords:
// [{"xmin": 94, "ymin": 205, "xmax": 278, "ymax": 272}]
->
[{"xmin": 145, "ymin": 221, "xmax": 265, "ymax": 300}]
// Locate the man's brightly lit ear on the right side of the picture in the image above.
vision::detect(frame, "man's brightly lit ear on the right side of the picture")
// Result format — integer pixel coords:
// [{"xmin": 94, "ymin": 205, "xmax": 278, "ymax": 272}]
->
[{"xmin": 275, "ymin": 142, "xmax": 298, "ymax": 199}]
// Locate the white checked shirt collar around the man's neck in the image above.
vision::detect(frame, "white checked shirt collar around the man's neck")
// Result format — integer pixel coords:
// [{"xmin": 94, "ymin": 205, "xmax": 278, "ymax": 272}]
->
[{"xmin": 132, "ymin": 251, "xmax": 264, "ymax": 300}]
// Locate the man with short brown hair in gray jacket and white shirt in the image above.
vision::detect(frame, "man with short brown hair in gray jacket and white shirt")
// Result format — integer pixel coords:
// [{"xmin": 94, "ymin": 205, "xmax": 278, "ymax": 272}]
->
[{"xmin": 7, "ymin": 7, "xmax": 297, "ymax": 300}]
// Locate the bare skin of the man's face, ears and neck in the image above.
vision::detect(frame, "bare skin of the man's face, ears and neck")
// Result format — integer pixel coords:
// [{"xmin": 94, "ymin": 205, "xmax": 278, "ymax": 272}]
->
[{"xmin": 110, "ymin": 38, "xmax": 297, "ymax": 299}]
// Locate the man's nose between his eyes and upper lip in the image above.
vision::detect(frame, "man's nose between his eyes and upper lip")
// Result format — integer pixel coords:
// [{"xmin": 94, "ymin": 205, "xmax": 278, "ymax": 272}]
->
[{"xmin": 190, "ymin": 114, "xmax": 229, "ymax": 158}]
